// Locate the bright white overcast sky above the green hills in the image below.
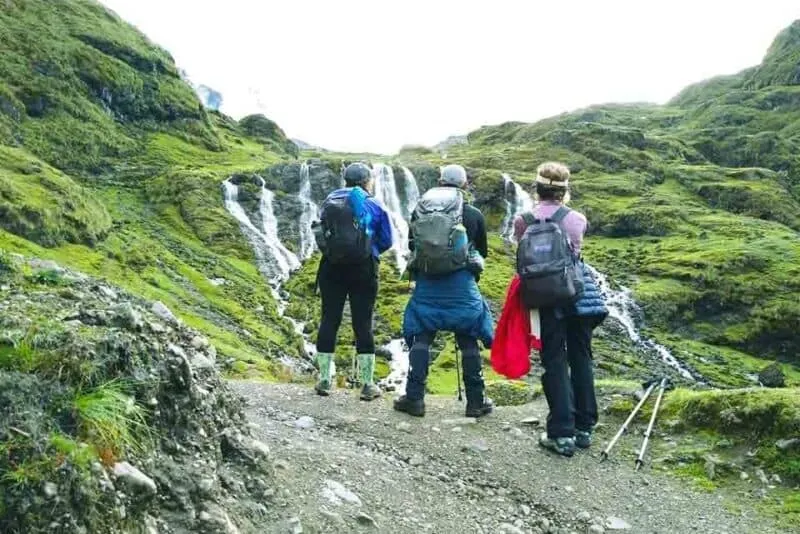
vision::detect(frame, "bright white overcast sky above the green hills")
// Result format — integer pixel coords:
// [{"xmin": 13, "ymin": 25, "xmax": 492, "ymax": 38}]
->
[{"xmin": 101, "ymin": 0, "xmax": 800, "ymax": 153}]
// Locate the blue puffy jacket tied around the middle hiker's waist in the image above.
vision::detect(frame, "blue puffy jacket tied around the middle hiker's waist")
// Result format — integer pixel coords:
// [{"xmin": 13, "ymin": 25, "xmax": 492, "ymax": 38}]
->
[{"xmin": 403, "ymin": 269, "xmax": 494, "ymax": 347}]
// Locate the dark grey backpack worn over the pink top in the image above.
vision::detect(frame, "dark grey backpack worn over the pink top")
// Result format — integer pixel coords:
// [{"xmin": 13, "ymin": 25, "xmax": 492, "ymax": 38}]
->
[{"xmin": 517, "ymin": 206, "xmax": 583, "ymax": 309}]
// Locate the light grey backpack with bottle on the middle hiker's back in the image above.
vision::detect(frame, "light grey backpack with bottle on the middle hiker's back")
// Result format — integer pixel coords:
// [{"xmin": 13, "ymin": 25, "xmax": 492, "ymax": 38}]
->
[{"xmin": 409, "ymin": 187, "xmax": 469, "ymax": 275}]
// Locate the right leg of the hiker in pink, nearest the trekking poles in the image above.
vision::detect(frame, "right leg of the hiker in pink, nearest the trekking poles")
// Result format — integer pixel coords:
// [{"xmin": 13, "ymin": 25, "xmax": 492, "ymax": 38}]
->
[{"xmin": 567, "ymin": 317, "xmax": 597, "ymax": 448}]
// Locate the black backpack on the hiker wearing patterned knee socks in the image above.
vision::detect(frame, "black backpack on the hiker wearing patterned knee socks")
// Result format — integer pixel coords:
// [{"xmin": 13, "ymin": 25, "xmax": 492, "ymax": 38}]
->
[{"xmin": 312, "ymin": 195, "xmax": 372, "ymax": 264}]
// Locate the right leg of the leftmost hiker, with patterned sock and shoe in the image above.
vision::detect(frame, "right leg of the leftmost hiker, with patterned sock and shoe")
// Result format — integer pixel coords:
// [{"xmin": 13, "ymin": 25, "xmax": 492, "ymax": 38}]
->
[{"xmin": 348, "ymin": 261, "xmax": 381, "ymax": 400}]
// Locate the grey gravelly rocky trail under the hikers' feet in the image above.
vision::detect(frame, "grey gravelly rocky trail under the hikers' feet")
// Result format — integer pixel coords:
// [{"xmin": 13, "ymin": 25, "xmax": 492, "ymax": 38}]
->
[{"xmin": 231, "ymin": 382, "xmax": 778, "ymax": 534}]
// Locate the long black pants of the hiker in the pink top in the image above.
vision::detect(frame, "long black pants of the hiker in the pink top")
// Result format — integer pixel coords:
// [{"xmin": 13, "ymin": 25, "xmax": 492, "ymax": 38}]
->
[{"xmin": 539, "ymin": 309, "xmax": 597, "ymax": 438}]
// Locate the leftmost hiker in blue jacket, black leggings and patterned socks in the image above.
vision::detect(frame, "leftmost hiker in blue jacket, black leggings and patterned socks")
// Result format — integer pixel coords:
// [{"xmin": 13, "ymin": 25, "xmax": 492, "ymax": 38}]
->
[{"xmin": 312, "ymin": 163, "xmax": 392, "ymax": 401}]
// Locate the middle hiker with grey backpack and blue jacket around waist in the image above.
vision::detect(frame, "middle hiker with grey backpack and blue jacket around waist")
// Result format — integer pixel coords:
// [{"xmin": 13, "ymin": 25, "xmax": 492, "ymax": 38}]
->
[{"xmin": 394, "ymin": 165, "xmax": 493, "ymax": 417}]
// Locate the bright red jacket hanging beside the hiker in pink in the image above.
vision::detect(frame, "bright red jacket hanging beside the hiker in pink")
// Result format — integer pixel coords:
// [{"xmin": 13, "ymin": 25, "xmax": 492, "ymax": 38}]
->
[{"xmin": 491, "ymin": 275, "xmax": 542, "ymax": 379}]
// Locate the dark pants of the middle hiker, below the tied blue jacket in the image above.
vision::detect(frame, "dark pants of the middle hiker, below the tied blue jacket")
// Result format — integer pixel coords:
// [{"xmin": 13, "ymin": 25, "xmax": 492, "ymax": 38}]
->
[{"xmin": 406, "ymin": 332, "xmax": 484, "ymax": 406}]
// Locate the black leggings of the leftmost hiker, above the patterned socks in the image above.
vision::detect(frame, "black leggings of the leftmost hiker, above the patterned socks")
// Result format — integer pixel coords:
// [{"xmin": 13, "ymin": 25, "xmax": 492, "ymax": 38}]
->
[{"xmin": 317, "ymin": 258, "xmax": 378, "ymax": 354}]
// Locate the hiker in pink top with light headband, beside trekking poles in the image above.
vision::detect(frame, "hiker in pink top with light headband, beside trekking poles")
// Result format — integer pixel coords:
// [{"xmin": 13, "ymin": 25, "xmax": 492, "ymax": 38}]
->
[{"xmin": 514, "ymin": 162, "xmax": 608, "ymax": 456}]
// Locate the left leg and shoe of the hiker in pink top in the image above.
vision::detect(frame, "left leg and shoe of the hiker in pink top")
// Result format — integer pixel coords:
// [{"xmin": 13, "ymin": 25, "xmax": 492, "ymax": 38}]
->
[{"xmin": 539, "ymin": 308, "xmax": 575, "ymax": 456}]
